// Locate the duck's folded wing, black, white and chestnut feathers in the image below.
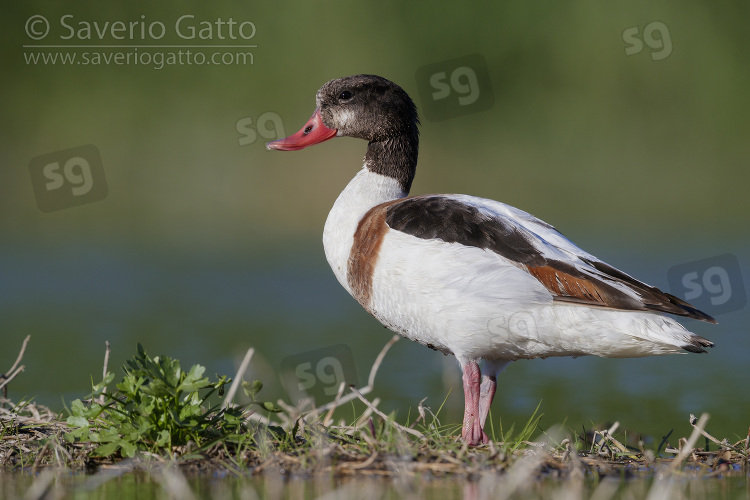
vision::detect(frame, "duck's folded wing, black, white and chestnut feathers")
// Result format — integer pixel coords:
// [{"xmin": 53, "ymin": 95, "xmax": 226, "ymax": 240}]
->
[{"xmin": 383, "ymin": 195, "xmax": 716, "ymax": 323}]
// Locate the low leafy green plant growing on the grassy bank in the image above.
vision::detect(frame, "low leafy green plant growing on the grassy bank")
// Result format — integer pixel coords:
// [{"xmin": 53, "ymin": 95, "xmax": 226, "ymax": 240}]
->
[{"xmin": 65, "ymin": 344, "xmax": 278, "ymax": 457}]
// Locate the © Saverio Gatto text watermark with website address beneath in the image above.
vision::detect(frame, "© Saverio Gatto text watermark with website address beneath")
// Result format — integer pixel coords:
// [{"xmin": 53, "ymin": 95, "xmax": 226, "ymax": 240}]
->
[{"xmin": 23, "ymin": 14, "xmax": 257, "ymax": 70}]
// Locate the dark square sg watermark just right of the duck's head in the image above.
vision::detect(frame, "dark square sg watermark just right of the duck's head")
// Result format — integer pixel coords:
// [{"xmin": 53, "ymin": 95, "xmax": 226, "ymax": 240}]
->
[{"xmin": 416, "ymin": 54, "xmax": 495, "ymax": 121}]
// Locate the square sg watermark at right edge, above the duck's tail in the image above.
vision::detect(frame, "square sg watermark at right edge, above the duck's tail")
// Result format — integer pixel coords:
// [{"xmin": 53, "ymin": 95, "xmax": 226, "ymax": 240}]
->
[{"xmin": 667, "ymin": 254, "xmax": 747, "ymax": 316}]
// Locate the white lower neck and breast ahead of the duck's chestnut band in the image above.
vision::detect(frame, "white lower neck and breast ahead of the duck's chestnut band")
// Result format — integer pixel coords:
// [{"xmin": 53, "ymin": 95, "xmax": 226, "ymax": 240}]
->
[{"xmin": 323, "ymin": 167, "xmax": 409, "ymax": 293}]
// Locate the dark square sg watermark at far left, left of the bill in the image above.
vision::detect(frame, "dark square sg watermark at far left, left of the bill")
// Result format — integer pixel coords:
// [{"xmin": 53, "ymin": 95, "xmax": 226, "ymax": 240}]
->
[{"xmin": 29, "ymin": 144, "xmax": 107, "ymax": 212}]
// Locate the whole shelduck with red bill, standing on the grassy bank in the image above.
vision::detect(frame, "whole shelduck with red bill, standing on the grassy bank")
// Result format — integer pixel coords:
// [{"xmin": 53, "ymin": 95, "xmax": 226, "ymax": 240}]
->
[{"xmin": 266, "ymin": 74, "xmax": 716, "ymax": 446}]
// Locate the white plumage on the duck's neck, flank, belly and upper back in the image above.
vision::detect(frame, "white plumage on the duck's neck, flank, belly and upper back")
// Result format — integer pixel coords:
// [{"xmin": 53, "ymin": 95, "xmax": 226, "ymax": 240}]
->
[{"xmin": 323, "ymin": 167, "xmax": 704, "ymax": 365}]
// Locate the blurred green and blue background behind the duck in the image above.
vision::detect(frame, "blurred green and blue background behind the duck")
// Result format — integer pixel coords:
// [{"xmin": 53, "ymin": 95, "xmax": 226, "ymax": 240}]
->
[{"xmin": 0, "ymin": 0, "xmax": 750, "ymax": 441}]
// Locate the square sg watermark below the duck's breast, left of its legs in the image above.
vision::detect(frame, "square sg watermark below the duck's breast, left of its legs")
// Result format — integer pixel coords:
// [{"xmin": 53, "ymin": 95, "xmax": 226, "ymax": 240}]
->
[{"xmin": 281, "ymin": 344, "xmax": 357, "ymax": 405}]
